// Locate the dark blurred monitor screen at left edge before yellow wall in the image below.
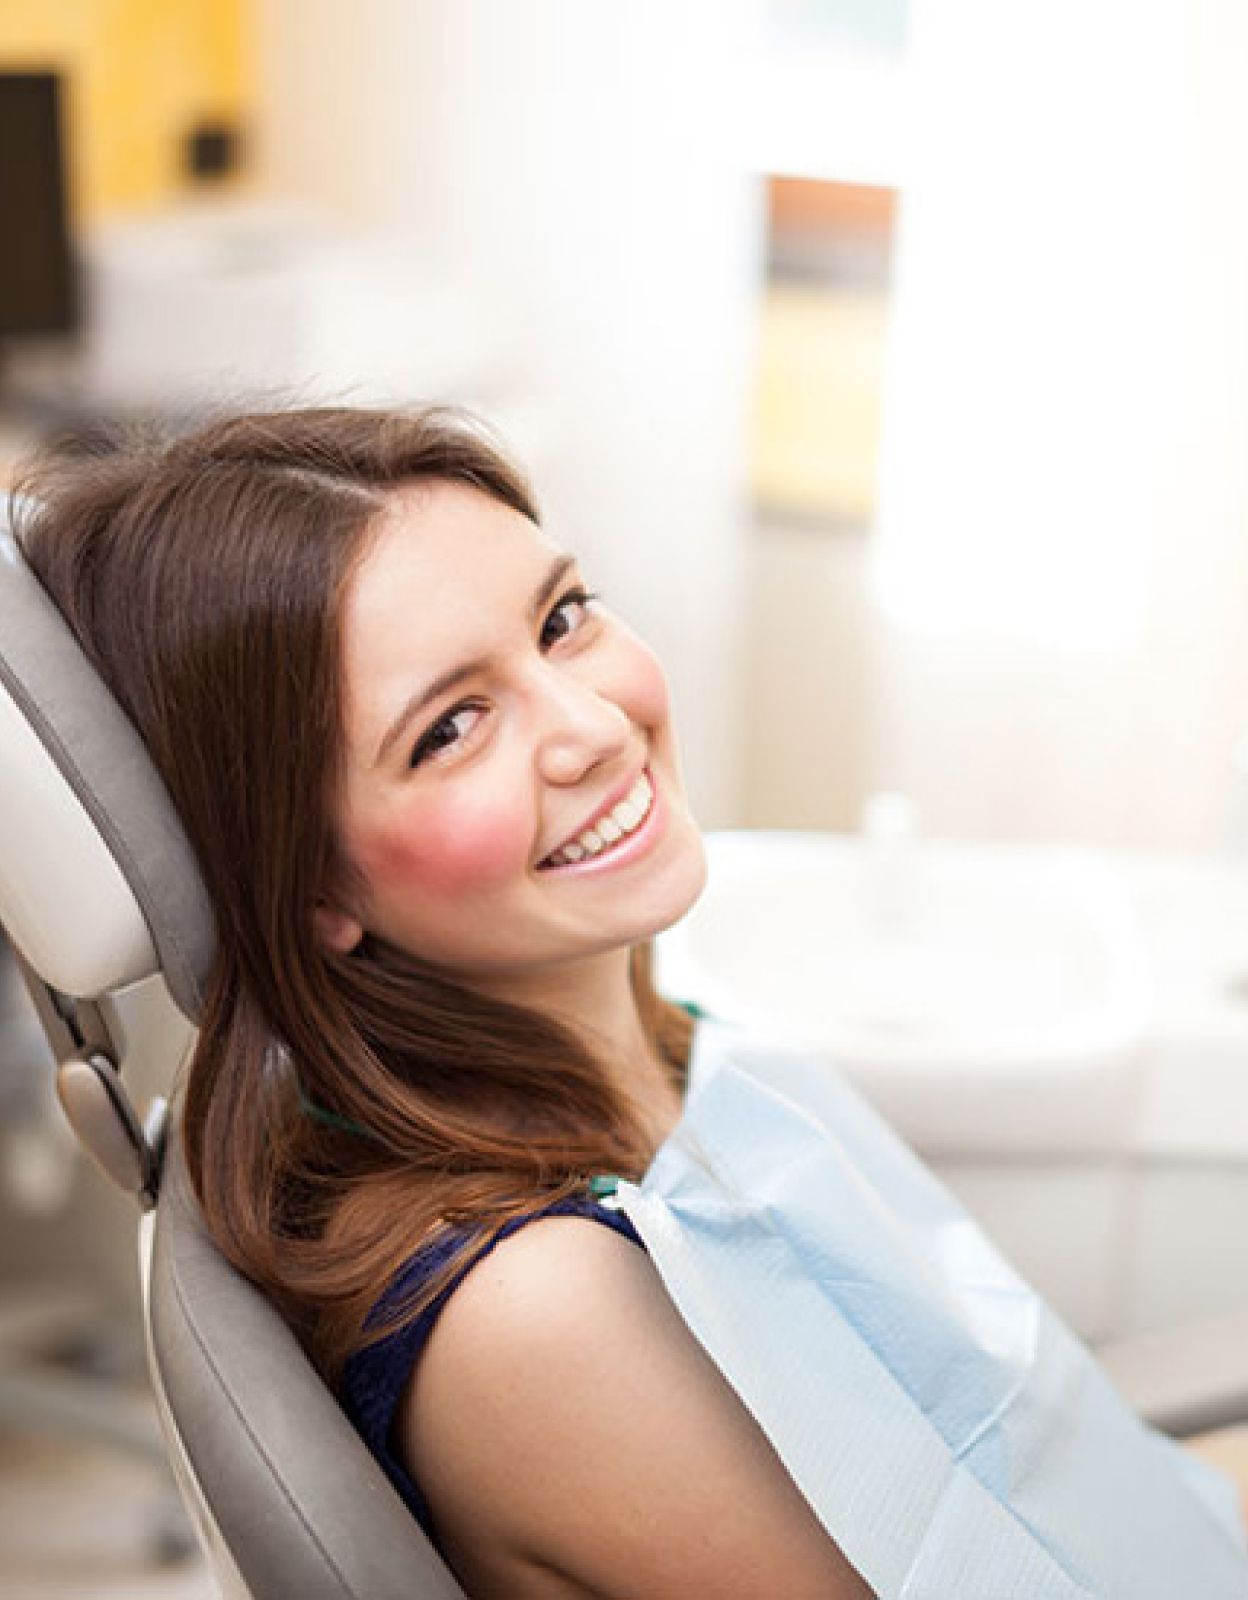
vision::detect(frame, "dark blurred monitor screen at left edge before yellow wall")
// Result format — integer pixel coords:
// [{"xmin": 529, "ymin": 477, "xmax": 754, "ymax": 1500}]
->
[{"xmin": 0, "ymin": 72, "xmax": 77, "ymax": 336}]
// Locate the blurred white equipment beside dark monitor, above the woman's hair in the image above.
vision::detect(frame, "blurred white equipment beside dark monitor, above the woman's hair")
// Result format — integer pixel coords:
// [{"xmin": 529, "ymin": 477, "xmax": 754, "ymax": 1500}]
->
[{"xmin": 6, "ymin": 198, "xmax": 541, "ymax": 451}]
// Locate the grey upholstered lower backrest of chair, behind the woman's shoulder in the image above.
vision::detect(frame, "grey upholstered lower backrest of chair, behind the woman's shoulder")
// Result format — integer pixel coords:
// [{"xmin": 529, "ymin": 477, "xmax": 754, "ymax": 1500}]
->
[{"xmin": 147, "ymin": 1138, "xmax": 462, "ymax": 1600}]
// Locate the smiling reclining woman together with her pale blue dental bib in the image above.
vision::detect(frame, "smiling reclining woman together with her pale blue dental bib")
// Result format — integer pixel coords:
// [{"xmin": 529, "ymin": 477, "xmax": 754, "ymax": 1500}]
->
[{"xmin": 21, "ymin": 410, "xmax": 1248, "ymax": 1600}]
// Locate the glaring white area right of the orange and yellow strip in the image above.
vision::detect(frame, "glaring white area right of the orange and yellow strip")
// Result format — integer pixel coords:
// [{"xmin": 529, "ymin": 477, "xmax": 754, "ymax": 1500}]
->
[{"xmin": 872, "ymin": 0, "xmax": 1248, "ymax": 848}]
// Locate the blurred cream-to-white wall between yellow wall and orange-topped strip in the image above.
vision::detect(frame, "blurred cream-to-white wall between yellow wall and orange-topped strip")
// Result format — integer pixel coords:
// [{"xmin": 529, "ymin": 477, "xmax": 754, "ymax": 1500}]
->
[{"xmin": 259, "ymin": 0, "xmax": 760, "ymax": 826}]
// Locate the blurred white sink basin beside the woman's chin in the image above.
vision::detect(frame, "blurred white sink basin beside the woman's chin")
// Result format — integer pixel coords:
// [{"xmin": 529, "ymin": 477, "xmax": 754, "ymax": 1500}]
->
[{"xmin": 658, "ymin": 832, "xmax": 1149, "ymax": 1152}]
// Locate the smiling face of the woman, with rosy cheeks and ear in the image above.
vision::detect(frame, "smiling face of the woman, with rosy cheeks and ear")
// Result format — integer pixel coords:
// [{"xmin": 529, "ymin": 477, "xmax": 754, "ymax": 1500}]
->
[{"xmin": 318, "ymin": 483, "xmax": 706, "ymax": 981}]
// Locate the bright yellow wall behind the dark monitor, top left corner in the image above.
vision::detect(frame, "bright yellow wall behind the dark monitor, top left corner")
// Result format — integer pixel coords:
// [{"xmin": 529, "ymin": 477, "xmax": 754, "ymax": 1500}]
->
[{"xmin": 0, "ymin": 0, "xmax": 250, "ymax": 219}]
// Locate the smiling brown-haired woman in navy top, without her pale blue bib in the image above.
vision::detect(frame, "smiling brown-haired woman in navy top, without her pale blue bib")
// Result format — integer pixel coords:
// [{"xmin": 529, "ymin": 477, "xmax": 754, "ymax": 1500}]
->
[{"xmin": 22, "ymin": 410, "xmax": 869, "ymax": 1600}]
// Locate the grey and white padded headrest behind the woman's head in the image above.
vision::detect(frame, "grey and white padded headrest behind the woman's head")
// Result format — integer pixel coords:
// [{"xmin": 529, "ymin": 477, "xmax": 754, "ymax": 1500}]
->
[{"xmin": 0, "ymin": 504, "xmax": 216, "ymax": 1021}]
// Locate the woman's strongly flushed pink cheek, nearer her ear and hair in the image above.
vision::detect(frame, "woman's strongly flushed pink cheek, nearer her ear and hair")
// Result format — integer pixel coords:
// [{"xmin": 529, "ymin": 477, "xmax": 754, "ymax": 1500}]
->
[{"xmin": 355, "ymin": 797, "xmax": 534, "ymax": 898}]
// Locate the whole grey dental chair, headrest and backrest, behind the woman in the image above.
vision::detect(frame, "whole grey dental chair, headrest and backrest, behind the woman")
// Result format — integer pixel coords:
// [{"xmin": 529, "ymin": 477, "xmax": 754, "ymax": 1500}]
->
[{"xmin": 0, "ymin": 502, "xmax": 462, "ymax": 1600}]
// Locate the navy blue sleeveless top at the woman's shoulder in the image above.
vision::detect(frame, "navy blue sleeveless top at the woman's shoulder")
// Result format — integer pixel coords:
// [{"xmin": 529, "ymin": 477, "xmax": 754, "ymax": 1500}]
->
[{"xmin": 341, "ymin": 1195, "xmax": 645, "ymax": 1542}]
